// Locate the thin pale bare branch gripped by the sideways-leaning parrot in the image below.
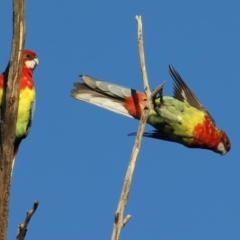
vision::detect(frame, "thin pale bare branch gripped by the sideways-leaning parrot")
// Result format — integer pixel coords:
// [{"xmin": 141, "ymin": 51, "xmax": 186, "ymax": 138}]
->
[{"xmin": 112, "ymin": 16, "xmax": 152, "ymax": 240}]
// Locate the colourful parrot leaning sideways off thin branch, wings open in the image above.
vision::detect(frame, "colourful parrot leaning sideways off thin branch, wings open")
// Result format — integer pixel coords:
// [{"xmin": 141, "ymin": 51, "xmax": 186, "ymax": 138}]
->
[{"xmin": 71, "ymin": 65, "xmax": 231, "ymax": 155}]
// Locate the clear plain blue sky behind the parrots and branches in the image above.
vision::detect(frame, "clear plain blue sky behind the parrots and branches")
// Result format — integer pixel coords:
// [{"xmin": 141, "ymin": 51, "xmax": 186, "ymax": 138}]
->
[{"xmin": 0, "ymin": 0, "xmax": 240, "ymax": 240}]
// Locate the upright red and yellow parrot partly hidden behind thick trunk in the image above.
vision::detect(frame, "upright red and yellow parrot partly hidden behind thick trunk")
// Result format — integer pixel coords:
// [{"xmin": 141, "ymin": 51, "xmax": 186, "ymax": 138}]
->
[{"xmin": 0, "ymin": 50, "xmax": 39, "ymax": 171}]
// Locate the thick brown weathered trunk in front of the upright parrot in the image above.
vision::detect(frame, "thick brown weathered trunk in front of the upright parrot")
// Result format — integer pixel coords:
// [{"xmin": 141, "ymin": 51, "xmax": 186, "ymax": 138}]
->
[{"xmin": 0, "ymin": 0, "xmax": 25, "ymax": 240}]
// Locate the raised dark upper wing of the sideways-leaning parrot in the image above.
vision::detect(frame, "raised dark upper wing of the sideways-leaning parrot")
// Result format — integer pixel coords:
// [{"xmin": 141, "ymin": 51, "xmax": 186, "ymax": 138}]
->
[{"xmin": 169, "ymin": 65, "xmax": 215, "ymax": 125}]
